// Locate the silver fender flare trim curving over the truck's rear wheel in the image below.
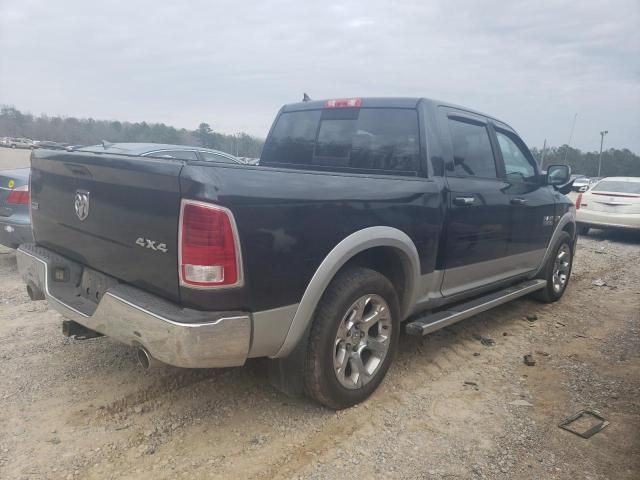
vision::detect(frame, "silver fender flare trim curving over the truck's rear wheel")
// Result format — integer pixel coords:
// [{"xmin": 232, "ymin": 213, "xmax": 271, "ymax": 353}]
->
[{"xmin": 272, "ymin": 226, "xmax": 420, "ymax": 358}]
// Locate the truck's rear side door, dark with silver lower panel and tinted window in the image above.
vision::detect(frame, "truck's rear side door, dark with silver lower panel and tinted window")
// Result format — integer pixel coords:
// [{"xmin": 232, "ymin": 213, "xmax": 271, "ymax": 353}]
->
[{"xmin": 441, "ymin": 110, "xmax": 510, "ymax": 296}]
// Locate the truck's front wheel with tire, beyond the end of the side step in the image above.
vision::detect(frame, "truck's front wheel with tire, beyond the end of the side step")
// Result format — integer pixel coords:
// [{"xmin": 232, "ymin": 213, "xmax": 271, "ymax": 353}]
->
[{"xmin": 533, "ymin": 232, "xmax": 574, "ymax": 303}]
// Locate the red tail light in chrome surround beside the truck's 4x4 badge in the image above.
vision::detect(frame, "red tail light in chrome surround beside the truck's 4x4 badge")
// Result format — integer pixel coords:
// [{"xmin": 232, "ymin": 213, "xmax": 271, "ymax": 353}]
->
[{"xmin": 178, "ymin": 200, "xmax": 242, "ymax": 288}]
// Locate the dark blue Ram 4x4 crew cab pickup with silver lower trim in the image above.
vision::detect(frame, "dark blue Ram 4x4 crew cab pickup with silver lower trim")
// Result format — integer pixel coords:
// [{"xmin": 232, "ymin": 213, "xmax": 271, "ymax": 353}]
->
[{"xmin": 18, "ymin": 98, "xmax": 576, "ymax": 408}]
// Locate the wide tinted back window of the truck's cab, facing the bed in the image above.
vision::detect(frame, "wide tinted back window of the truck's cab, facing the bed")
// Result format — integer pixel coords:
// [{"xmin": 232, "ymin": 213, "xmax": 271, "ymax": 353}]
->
[{"xmin": 261, "ymin": 108, "xmax": 420, "ymax": 172}]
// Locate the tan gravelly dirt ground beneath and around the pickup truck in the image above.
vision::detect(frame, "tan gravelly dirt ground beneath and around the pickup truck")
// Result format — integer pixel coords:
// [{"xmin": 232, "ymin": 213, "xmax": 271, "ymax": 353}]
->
[{"xmin": 0, "ymin": 148, "xmax": 640, "ymax": 480}]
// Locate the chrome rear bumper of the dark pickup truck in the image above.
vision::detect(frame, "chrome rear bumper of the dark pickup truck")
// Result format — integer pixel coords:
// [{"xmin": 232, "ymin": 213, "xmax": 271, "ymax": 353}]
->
[{"xmin": 17, "ymin": 244, "xmax": 251, "ymax": 368}]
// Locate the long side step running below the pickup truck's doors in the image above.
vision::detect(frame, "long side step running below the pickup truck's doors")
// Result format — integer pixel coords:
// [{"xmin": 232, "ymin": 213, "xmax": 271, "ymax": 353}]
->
[{"xmin": 405, "ymin": 280, "xmax": 547, "ymax": 336}]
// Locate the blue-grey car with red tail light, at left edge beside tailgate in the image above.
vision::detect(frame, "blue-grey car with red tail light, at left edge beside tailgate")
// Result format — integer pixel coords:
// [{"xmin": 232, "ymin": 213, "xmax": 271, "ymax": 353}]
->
[{"xmin": 0, "ymin": 168, "xmax": 33, "ymax": 248}]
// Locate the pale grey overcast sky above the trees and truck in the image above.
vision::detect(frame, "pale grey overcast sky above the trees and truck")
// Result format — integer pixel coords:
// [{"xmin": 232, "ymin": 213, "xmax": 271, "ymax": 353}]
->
[{"xmin": 0, "ymin": 0, "xmax": 640, "ymax": 153}]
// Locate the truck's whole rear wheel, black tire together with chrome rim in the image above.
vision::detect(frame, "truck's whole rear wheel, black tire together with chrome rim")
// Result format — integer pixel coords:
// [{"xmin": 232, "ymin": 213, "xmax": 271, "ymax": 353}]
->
[{"xmin": 304, "ymin": 267, "xmax": 400, "ymax": 410}]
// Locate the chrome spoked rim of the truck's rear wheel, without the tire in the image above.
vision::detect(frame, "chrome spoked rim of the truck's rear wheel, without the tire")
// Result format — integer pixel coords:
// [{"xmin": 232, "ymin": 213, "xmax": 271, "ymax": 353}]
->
[{"xmin": 333, "ymin": 295, "xmax": 392, "ymax": 389}]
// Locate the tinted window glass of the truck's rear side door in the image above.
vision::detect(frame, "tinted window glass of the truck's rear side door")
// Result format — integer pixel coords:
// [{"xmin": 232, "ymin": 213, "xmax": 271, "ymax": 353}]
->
[{"xmin": 447, "ymin": 118, "xmax": 498, "ymax": 178}]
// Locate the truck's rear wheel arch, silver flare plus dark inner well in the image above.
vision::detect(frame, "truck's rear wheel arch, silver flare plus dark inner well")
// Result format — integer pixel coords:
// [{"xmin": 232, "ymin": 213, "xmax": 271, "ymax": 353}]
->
[{"xmin": 274, "ymin": 226, "xmax": 420, "ymax": 358}]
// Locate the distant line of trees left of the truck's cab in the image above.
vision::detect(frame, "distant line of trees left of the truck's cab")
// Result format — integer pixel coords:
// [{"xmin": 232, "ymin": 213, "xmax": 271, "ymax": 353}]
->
[{"xmin": 0, "ymin": 105, "xmax": 264, "ymax": 158}]
